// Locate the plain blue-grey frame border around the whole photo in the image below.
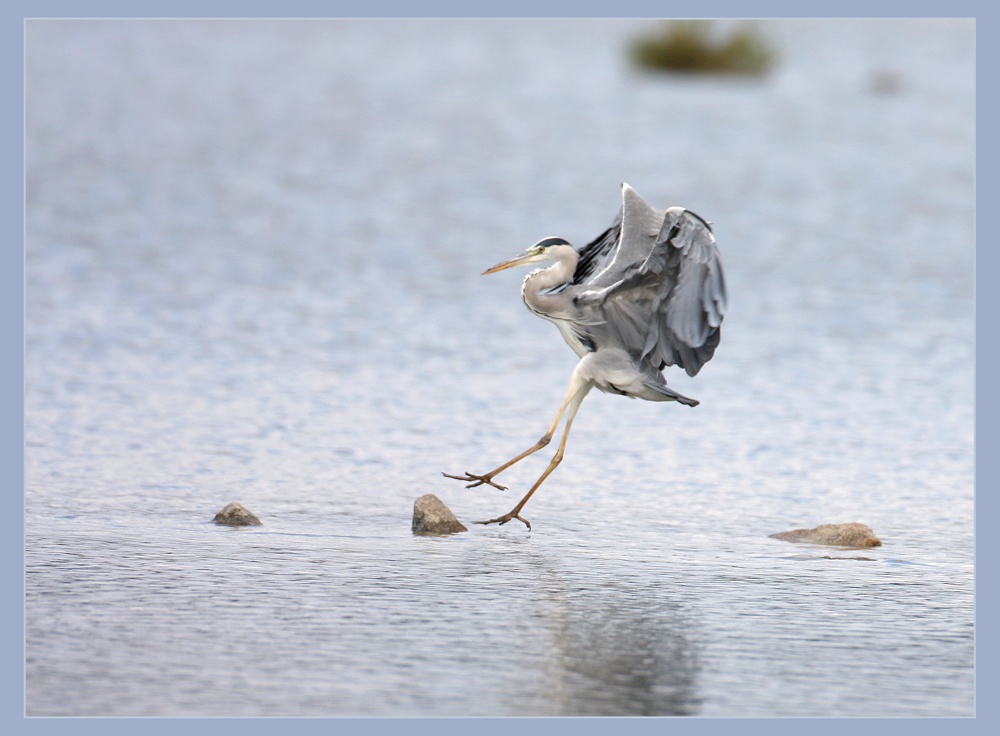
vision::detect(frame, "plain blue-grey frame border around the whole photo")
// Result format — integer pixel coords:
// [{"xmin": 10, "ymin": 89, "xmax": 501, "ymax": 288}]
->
[{"xmin": 0, "ymin": 0, "xmax": 1000, "ymax": 736}]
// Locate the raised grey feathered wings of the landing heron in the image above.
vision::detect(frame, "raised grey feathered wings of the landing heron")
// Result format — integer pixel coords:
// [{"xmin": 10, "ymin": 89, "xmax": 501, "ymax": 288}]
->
[{"xmin": 569, "ymin": 184, "xmax": 726, "ymax": 376}]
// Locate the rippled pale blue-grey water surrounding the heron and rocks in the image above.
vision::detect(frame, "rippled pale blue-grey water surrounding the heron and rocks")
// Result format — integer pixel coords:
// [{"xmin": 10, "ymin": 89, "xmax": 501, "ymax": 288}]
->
[{"xmin": 25, "ymin": 20, "xmax": 975, "ymax": 716}]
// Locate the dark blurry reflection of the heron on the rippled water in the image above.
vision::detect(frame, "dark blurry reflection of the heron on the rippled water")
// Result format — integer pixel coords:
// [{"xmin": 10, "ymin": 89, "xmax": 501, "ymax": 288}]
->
[{"xmin": 536, "ymin": 560, "xmax": 700, "ymax": 716}]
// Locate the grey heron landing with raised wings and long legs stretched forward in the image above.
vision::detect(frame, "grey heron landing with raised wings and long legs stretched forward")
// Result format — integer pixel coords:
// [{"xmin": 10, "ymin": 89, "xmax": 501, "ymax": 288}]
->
[{"xmin": 442, "ymin": 183, "xmax": 727, "ymax": 531}]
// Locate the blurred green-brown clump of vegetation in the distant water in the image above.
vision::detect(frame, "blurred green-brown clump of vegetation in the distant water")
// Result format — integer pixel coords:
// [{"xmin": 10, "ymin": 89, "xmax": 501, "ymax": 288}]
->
[{"xmin": 630, "ymin": 20, "xmax": 774, "ymax": 76}]
